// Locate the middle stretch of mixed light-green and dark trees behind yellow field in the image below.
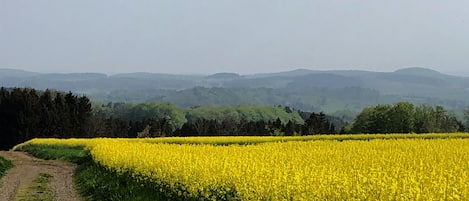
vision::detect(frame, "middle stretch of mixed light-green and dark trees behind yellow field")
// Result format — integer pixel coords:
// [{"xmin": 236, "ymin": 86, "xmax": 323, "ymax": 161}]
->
[{"xmin": 89, "ymin": 103, "xmax": 337, "ymax": 137}]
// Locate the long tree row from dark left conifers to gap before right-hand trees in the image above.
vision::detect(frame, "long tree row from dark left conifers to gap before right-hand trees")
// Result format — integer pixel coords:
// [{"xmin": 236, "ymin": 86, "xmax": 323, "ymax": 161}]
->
[{"xmin": 0, "ymin": 87, "xmax": 336, "ymax": 149}]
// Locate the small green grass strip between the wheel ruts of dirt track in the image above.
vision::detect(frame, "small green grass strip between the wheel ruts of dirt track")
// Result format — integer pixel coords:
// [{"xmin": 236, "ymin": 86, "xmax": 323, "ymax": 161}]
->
[{"xmin": 15, "ymin": 173, "xmax": 54, "ymax": 201}]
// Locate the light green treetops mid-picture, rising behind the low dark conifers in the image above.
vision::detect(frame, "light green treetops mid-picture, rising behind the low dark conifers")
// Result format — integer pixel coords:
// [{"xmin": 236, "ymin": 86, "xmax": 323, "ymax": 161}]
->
[{"xmin": 93, "ymin": 102, "xmax": 303, "ymax": 126}]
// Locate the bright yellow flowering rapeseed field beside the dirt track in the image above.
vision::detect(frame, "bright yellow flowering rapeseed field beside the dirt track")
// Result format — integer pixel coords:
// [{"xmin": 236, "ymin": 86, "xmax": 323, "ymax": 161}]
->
[{"xmin": 12, "ymin": 134, "xmax": 469, "ymax": 200}]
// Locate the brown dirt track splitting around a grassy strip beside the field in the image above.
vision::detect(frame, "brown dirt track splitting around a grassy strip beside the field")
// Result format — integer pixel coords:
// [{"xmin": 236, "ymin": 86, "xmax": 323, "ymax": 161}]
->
[{"xmin": 0, "ymin": 151, "xmax": 80, "ymax": 201}]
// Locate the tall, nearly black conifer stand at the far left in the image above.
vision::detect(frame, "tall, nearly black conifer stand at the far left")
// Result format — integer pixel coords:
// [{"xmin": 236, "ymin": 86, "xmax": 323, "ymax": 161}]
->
[{"xmin": 0, "ymin": 87, "xmax": 93, "ymax": 149}]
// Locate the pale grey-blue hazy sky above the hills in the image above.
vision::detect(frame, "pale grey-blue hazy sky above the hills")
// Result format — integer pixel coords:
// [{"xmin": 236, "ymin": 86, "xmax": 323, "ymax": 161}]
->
[{"xmin": 0, "ymin": 0, "xmax": 469, "ymax": 74}]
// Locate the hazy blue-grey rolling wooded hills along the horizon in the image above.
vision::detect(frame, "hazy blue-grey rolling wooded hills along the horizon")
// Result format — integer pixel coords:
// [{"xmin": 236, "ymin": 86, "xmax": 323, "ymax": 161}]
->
[{"xmin": 0, "ymin": 68, "xmax": 469, "ymax": 113}]
